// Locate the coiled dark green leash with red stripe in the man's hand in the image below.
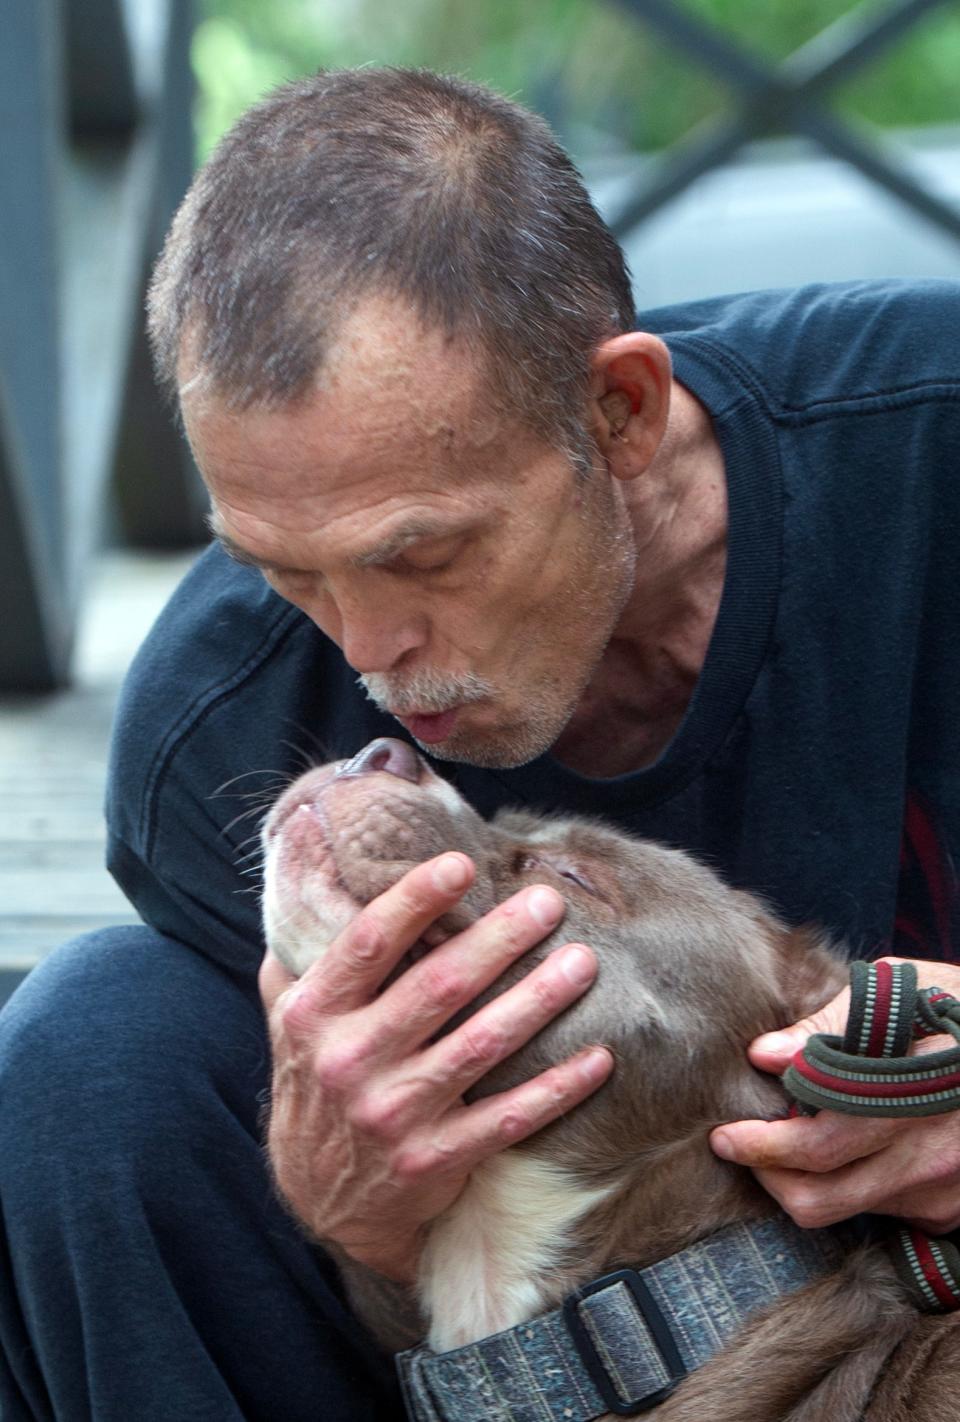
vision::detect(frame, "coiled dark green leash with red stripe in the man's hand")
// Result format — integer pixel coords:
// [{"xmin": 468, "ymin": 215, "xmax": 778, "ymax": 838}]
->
[{"xmin": 784, "ymin": 961, "xmax": 960, "ymax": 1313}]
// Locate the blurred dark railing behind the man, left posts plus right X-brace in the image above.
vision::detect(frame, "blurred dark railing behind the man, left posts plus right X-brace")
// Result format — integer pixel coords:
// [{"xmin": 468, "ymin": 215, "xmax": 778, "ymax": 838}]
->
[{"xmin": 0, "ymin": 0, "xmax": 960, "ymax": 690}]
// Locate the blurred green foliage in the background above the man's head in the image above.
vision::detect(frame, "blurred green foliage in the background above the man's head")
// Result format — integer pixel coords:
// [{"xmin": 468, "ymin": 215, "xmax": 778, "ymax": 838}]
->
[{"xmin": 193, "ymin": 0, "xmax": 960, "ymax": 158}]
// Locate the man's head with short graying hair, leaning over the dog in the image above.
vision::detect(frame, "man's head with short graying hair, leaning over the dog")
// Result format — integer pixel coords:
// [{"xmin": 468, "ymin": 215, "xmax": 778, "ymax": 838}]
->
[{"xmin": 151, "ymin": 70, "xmax": 668, "ymax": 765}]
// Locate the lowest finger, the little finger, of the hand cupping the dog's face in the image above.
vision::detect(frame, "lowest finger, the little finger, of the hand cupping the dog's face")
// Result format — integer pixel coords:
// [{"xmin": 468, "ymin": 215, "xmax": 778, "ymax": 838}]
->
[{"xmin": 397, "ymin": 1047, "xmax": 614, "ymax": 1177}]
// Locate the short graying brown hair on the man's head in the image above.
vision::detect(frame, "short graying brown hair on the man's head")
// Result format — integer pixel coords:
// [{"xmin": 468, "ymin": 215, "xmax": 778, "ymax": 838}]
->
[{"xmin": 148, "ymin": 68, "xmax": 634, "ymax": 462}]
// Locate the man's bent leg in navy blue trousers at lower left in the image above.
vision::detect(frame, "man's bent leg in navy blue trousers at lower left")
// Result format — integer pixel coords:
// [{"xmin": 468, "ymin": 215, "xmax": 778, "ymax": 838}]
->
[{"xmin": 0, "ymin": 929, "xmax": 400, "ymax": 1422}]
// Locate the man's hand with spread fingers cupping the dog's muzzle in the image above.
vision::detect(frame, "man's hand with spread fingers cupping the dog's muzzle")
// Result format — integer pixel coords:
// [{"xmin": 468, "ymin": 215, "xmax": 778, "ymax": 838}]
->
[{"xmin": 260, "ymin": 853, "xmax": 613, "ymax": 1283}]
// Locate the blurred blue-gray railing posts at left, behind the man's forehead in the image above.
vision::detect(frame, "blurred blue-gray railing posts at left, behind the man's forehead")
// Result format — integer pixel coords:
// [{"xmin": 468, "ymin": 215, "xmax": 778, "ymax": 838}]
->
[{"xmin": 0, "ymin": 0, "xmax": 201, "ymax": 690}]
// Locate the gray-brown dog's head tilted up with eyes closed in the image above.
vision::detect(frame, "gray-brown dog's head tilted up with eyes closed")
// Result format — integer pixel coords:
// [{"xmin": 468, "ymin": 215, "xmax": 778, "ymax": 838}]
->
[{"xmin": 263, "ymin": 739, "xmax": 842, "ymax": 1160}]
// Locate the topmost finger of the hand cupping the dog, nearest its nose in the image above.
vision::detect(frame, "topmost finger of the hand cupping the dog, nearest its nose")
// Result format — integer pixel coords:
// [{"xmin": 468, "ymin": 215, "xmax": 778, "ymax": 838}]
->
[{"xmin": 300, "ymin": 853, "xmax": 474, "ymax": 1012}]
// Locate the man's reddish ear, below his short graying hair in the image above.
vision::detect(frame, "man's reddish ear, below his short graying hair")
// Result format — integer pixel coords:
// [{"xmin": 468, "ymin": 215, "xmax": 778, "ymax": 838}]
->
[{"xmin": 590, "ymin": 331, "xmax": 673, "ymax": 479}]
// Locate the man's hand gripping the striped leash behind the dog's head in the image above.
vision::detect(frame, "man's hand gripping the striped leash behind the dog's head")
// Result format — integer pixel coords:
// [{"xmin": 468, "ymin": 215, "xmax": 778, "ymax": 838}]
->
[{"xmin": 711, "ymin": 958, "xmax": 960, "ymax": 1234}]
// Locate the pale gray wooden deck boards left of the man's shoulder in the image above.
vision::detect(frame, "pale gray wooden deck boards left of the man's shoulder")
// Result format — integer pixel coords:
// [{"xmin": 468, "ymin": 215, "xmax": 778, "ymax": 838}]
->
[{"xmin": 0, "ymin": 552, "xmax": 197, "ymax": 1003}]
